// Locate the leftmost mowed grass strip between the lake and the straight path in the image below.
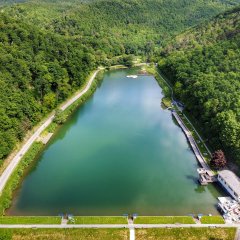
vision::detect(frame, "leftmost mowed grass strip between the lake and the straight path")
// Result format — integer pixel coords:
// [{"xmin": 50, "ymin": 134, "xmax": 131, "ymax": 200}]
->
[{"xmin": 0, "ymin": 216, "xmax": 61, "ymax": 224}]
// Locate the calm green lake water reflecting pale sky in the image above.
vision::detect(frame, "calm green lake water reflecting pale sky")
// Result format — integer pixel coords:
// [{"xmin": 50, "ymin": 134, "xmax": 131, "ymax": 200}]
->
[{"xmin": 9, "ymin": 69, "xmax": 221, "ymax": 215}]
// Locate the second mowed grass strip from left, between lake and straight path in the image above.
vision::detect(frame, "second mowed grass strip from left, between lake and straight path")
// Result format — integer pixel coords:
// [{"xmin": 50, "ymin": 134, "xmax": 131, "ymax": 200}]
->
[{"xmin": 68, "ymin": 216, "xmax": 128, "ymax": 224}]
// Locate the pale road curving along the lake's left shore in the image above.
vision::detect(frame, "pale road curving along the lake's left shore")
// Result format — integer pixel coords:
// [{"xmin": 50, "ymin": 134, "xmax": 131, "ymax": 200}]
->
[{"xmin": 0, "ymin": 70, "xmax": 100, "ymax": 195}]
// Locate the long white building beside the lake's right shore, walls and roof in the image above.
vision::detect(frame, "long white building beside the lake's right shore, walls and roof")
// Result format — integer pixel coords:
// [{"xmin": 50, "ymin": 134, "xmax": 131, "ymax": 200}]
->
[{"xmin": 218, "ymin": 170, "xmax": 240, "ymax": 202}]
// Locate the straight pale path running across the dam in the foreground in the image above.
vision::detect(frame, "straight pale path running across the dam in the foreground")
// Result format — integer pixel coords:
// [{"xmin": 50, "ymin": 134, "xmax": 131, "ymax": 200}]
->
[{"xmin": 0, "ymin": 224, "xmax": 240, "ymax": 229}]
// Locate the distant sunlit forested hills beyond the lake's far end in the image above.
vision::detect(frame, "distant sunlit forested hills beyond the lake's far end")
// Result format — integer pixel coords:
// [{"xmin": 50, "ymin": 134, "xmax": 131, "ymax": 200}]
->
[{"xmin": 2, "ymin": 0, "xmax": 240, "ymax": 57}]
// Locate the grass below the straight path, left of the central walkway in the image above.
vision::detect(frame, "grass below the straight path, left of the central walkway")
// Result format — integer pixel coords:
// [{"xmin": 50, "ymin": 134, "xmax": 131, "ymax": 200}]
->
[{"xmin": 0, "ymin": 229, "xmax": 129, "ymax": 240}]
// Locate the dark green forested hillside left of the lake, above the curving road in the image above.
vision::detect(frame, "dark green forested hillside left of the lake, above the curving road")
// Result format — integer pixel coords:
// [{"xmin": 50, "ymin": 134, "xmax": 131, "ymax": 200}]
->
[{"xmin": 0, "ymin": 14, "xmax": 95, "ymax": 159}]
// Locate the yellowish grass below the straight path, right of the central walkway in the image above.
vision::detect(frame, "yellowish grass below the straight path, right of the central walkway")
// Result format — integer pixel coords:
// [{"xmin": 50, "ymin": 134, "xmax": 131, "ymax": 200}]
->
[{"xmin": 136, "ymin": 228, "xmax": 236, "ymax": 240}]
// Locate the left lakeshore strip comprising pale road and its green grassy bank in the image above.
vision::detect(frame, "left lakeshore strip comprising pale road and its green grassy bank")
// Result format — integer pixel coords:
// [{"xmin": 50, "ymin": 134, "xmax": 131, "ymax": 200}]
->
[{"xmin": 0, "ymin": 68, "xmax": 102, "ymax": 215}]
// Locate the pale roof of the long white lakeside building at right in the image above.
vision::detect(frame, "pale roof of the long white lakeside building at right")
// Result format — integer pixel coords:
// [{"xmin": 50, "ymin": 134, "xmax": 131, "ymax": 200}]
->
[{"xmin": 218, "ymin": 170, "xmax": 240, "ymax": 196}]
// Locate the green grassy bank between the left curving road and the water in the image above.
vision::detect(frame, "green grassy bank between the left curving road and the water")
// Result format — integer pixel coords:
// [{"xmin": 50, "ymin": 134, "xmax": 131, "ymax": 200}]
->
[{"xmin": 0, "ymin": 69, "xmax": 101, "ymax": 215}]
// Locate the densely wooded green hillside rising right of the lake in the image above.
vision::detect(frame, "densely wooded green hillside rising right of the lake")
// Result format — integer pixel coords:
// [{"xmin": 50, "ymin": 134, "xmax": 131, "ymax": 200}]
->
[{"xmin": 159, "ymin": 8, "xmax": 240, "ymax": 164}]
